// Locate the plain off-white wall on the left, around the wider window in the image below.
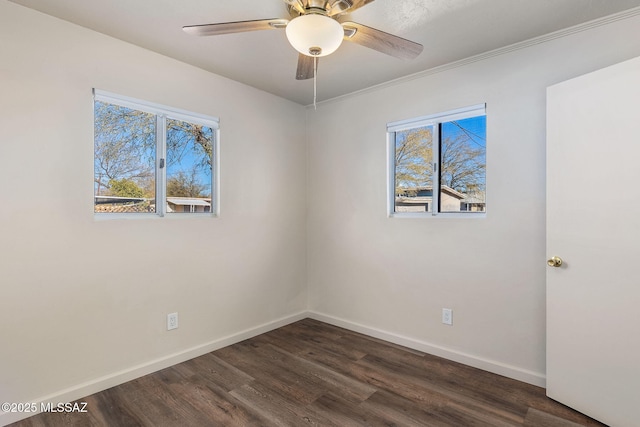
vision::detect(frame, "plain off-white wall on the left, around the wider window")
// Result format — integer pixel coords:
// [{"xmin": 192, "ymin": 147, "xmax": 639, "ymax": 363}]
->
[{"xmin": 0, "ymin": 1, "xmax": 307, "ymax": 425}]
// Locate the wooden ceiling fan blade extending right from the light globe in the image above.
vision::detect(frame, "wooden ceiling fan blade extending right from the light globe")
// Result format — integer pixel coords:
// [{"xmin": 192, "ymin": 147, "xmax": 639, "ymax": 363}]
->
[{"xmin": 342, "ymin": 21, "xmax": 422, "ymax": 59}]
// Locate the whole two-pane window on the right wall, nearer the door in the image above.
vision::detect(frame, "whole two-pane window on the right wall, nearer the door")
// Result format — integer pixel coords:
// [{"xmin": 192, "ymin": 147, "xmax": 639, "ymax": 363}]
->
[{"xmin": 387, "ymin": 104, "xmax": 487, "ymax": 216}]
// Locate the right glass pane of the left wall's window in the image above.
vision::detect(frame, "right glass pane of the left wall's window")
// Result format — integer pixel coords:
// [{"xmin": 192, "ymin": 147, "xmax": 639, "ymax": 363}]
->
[{"xmin": 167, "ymin": 119, "xmax": 213, "ymax": 213}]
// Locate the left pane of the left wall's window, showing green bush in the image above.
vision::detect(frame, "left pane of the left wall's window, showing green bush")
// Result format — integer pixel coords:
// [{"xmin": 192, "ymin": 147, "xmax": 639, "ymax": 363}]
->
[{"xmin": 94, "ymin": 101, "xmax": 156, "ymax": 213}]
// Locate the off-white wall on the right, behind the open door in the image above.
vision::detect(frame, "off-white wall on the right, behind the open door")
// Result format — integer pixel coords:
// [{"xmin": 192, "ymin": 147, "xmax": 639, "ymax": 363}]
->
[{"xmin": 307, "ymin": 15, "xmax": 640, "ymax": 385}]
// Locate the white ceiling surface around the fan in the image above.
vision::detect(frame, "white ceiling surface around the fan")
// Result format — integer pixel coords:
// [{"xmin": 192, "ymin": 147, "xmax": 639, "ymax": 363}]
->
[{"xmin": 11, "ymin": 0, "xmax": 640, "ymax": 105}]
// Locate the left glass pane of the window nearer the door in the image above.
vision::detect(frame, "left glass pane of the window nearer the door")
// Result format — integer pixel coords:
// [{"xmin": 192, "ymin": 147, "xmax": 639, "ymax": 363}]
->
[{"xmin": 394, "ymin": 126, "xmax": 433, "ymax": 212}]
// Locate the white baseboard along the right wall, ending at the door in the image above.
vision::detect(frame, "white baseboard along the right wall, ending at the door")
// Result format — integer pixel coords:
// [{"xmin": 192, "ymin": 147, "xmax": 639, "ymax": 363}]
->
[{"xmin": 307, "ymin": 311, "xmax": 546, "ymax": 387}]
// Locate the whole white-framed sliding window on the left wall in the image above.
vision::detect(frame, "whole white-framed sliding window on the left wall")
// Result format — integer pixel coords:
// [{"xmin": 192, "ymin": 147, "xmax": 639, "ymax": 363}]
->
[{"xmin": 94, "ymin": 90, "xmax": 218, "ymax": 216}]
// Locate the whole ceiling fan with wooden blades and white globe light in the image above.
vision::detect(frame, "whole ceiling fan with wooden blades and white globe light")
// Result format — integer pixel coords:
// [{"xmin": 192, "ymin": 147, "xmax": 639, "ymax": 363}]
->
[{"xmin": 182, "ymin": 0, "xmax": 422, "ymax": 80}]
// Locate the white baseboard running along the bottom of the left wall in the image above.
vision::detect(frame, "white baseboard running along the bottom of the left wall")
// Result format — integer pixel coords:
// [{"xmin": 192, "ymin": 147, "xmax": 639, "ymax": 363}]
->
[{"xmin": 0, "ymin": 311, "xmax": 308, "ymax": 426}]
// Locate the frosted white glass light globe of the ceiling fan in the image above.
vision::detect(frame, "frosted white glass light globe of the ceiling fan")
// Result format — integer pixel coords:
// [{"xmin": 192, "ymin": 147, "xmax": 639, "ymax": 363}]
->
[{"xmin": 286, "ymin": 14, "xmax": 344, "ymax": 56}]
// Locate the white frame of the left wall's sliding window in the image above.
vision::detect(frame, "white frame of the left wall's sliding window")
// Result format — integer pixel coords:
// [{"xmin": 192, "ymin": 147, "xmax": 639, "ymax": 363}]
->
[{"xmin": 93, "ymin": 88, "xmax": 220, "ymax": 219}]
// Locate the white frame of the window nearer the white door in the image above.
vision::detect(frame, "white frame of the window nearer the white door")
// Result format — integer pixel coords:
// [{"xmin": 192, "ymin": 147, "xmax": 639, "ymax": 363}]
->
[{"xmin": 387, "ymin": 104, "xmax": 487, "ymax": 218}]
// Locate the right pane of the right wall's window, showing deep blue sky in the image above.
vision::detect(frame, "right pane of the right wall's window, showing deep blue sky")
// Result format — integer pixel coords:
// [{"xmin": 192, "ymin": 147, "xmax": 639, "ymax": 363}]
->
[{"xmin": 440, "ymin": 116, "xmax": 487, "ymax": 212}]
